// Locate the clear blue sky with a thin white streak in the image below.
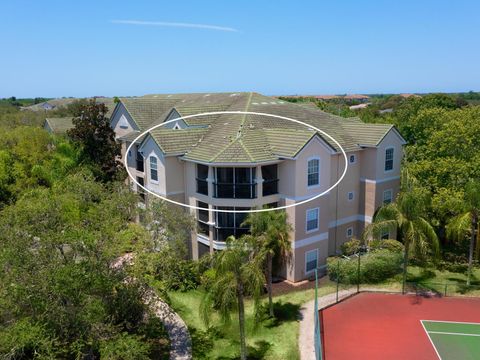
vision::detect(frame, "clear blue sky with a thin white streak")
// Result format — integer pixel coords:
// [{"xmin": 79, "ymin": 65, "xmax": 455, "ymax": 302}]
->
[{"xmin": 0, "ymin": 0, "xmax": 480, "ymax": 97}]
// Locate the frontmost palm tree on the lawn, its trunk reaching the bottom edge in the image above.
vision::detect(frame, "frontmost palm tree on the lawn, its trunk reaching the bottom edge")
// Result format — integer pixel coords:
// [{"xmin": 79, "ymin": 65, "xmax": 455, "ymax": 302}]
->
[{"xmin": 200, "ymin": 236, "xmax": 264, "ymax": 360}]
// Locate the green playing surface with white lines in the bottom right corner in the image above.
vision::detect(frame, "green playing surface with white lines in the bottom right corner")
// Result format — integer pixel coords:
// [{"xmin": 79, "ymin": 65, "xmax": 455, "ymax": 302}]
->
[{"xmin": 421, "ymin": 320, "xmax": 480, "ymax": 360}]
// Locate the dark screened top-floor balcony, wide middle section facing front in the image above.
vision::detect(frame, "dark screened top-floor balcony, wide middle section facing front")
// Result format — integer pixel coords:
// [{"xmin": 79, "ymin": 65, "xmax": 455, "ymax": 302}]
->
[{"xmin": 213, "ymin": 167, "xmax": 257, "ymax": 199}]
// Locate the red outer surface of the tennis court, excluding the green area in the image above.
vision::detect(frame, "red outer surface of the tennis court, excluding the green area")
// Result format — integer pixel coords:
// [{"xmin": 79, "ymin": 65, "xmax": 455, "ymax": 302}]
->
[{"xmin": 320, "ymin": 293, "xmax": 480, "ymax": 360}]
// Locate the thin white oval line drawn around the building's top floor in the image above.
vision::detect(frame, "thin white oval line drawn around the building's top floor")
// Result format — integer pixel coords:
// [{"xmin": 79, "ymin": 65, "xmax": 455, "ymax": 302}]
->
[{"xmin": 124, "ymin": 111, "xmax": 348, "ymax": 214}]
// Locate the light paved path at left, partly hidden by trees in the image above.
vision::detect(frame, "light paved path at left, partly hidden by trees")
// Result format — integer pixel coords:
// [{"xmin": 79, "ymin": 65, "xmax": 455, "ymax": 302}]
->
[{"xmin": 112, "ymin": 253, "xmax": 192, "ymax": 360}]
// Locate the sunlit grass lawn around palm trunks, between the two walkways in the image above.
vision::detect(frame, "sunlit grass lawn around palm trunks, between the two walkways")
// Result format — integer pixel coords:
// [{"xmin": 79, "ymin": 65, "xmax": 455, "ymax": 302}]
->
[{"xmin": 169, "ymin": 281, "xmax": 335, "ymax": 360}]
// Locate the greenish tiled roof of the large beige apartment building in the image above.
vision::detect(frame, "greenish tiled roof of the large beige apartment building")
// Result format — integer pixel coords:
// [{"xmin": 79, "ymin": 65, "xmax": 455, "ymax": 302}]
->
[{"xmin": 121, "ymin": 93, "xmax": 402, "ymax": 163}]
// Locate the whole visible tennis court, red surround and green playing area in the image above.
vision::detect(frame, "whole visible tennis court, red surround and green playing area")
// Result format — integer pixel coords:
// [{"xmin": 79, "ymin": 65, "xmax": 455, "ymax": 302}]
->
[{"xmin": 319, "ymin": 293, "xmax": 480, "ymax": 360}]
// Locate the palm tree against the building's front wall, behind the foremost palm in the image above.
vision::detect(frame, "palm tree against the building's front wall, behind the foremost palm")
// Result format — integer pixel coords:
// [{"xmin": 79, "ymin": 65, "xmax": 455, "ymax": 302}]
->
[{"xmin": 242, "ymin": 210, "xmax": 292, "ymax": 317}]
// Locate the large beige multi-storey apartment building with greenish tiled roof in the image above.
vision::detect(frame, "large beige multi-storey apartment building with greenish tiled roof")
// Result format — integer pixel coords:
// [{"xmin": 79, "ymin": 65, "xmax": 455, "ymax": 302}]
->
[{"xmin": 111, "ymin": 93, "xmax": 405, "ymax": 281}]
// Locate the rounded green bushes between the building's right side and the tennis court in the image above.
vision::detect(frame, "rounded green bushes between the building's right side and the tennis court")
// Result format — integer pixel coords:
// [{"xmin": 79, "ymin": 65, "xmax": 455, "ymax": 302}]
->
[{"xmin": 327, "ymin": 249, "xmax": 403, "ymax": 284}]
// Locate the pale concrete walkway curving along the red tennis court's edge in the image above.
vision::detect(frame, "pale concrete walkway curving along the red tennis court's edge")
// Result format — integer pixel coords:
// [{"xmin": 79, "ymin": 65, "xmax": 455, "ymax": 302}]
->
[{"xmin": 298, "ymin": 287, "xmax": 385, "ymax": 360}]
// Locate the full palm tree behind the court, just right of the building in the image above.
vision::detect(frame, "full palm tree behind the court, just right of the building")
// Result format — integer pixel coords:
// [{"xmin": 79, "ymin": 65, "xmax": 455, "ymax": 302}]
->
[{"xmin": 366, "ymin": 174, "xmax": 440, "ymax": 292}]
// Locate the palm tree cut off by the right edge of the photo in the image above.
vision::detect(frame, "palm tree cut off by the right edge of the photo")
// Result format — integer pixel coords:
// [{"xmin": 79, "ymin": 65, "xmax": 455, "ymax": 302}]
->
[{"xmin": 447, "ymin": 181, "xmax": 480, "ymax": 286}]
